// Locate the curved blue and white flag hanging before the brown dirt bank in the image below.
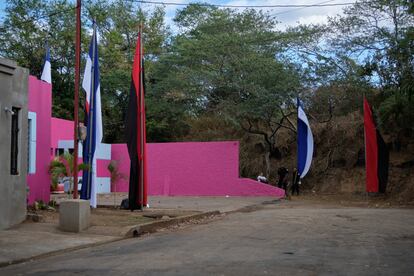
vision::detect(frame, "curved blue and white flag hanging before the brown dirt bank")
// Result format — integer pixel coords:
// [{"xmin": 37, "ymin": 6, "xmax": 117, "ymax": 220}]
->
[{"xmin": 298, "ymin": 98, "xmax": 313, "ymax": 178}]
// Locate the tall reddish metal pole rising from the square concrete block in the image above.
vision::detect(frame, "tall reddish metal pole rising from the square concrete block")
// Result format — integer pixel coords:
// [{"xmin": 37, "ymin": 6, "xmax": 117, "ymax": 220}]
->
[{"xmin": 73, "ymin": 0, "xmax": 81, "ymax": 199}]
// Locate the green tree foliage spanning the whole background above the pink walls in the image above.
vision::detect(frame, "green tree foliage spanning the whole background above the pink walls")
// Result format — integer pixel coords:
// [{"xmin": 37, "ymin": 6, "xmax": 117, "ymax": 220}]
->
[{"xmin": 0, "ymin": 0, "xmax": 414, "ymax": 179}]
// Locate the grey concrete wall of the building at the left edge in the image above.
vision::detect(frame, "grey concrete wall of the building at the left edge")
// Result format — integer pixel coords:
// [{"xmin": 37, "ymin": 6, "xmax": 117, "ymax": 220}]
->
[{"xmin": 0, "ymin": 58, "xmax": 29, "ymax": 229}]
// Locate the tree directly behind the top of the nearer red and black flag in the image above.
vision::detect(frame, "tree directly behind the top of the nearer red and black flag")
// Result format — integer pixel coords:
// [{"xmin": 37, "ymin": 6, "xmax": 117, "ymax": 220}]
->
[{"xmin": 87, "ymin": 0, "xmax": 171, "ymax": 143}]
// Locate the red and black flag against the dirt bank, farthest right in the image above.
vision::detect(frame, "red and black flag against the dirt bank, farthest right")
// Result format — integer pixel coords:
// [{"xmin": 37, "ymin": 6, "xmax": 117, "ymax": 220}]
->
[{"xmin": 364, "ymin": 98, "xmax": 389, "ymax": 193}]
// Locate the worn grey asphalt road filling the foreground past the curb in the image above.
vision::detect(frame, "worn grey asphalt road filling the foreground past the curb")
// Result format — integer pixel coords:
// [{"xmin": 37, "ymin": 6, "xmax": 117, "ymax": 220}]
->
[{"xmin": 0, "ymin": 204, "xmax": 414, "ymax": 276}]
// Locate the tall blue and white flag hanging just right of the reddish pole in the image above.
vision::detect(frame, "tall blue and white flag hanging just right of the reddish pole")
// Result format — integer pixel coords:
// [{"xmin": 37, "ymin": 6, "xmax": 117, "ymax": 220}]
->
[{"xmin": 81, "ymin": 23, "xmax": 103, "ymax": 207}]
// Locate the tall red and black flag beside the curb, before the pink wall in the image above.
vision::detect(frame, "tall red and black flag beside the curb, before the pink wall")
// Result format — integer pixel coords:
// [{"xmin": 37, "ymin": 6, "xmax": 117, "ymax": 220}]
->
[{"xmin": 126, "ymin": 32, "xmax": 147, "ymax": 210}]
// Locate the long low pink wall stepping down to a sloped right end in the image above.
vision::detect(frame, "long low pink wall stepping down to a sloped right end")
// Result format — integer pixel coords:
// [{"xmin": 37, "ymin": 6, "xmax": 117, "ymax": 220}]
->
[{"xmin": 111, "ymin": 141, "xmax": 284, "ymax": 197}]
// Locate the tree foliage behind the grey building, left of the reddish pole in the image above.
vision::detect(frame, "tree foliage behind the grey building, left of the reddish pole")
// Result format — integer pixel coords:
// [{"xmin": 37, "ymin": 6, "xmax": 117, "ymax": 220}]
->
[{"xmin": 0, "ymin": 0, "xmax": 88, "ymax": 119}]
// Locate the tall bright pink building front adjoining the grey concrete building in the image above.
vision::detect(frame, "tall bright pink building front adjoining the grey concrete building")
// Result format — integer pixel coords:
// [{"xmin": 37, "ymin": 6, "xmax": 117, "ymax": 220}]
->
[{"xmin": 27, "ymin": 76, "xmax": 52, "ymax": 204}]
